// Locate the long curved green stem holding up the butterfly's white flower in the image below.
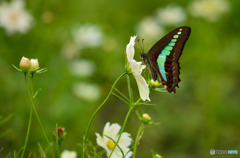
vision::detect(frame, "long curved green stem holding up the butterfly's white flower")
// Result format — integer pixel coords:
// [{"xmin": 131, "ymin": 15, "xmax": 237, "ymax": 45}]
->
[{"xmin": 82, "ymin": 72, "xmax": 126, "ymax": 158}]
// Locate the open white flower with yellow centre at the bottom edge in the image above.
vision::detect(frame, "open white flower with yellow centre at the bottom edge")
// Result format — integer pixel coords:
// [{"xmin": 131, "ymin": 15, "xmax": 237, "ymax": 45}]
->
[{"xmin": 96, "ymin": 122, "xmax": 132, "ymax": 158}]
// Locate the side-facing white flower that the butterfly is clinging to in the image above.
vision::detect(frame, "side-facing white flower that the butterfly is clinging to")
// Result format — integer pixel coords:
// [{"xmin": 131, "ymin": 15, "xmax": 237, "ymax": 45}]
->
[{"xmin": 126, "ymin": 36, "xmax": 150, "ymax": 101}]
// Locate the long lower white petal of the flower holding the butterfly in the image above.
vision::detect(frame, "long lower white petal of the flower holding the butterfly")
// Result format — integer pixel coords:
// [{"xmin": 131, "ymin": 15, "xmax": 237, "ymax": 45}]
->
[{"xmin": 135, "ymin": 75, "xmax": 150, "ymax": 101}]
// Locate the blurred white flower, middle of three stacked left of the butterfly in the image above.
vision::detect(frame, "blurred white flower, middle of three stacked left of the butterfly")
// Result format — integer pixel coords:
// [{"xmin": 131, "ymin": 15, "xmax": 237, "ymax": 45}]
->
[{"xmin": 69, "ymin": 59, "xmax": 96, "ymax": 77}]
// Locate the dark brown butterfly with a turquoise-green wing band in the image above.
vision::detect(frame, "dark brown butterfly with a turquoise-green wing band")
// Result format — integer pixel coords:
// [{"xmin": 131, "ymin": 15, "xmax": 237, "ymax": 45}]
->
[{"xmin": 140, "ymin": 26, "xmax": 191, "ymax": 93}]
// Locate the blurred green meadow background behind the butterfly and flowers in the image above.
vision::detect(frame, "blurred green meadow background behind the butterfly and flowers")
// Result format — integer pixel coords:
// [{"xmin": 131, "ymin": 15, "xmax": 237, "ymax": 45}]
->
[{"xmin": 0, "ymin": 0, "xmax": 240, "ymax": 158}]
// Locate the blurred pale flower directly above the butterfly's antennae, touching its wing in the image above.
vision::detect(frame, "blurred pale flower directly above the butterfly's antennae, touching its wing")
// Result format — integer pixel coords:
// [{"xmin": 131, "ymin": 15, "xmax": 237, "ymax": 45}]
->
[{"xmin": 136, "ymin": 17, "xmax": 164, "ymax": 41}]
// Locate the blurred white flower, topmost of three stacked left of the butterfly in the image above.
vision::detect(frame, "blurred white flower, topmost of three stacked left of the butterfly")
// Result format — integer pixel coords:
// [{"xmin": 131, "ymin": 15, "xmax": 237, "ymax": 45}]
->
[{"xmin": 73, "ymin": 24, "xmax": 103, "ymax": 48}]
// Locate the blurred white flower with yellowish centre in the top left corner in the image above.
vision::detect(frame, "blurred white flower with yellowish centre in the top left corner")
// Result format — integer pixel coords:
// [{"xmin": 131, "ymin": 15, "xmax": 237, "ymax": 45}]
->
[{"xmin": 0, "ymin": 0, "xmax": 33, "ymax": 35}]
